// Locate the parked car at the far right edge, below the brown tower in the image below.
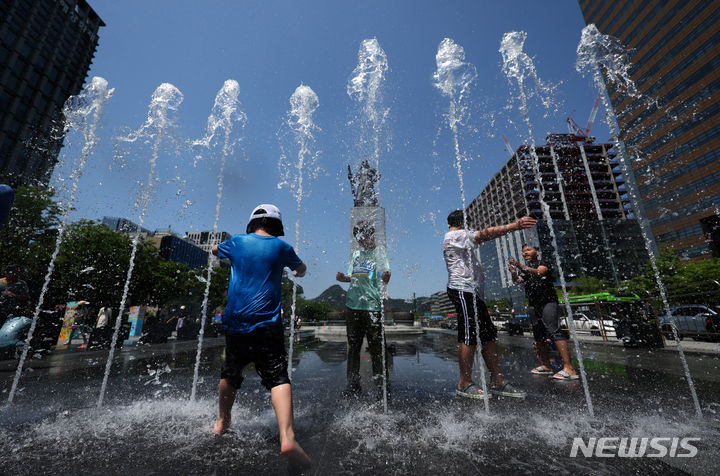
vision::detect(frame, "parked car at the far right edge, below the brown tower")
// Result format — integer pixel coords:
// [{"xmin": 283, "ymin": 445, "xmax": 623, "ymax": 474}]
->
[{"xmin": 659, "ymin": 304, "xmax": 720, "ymax": 340}]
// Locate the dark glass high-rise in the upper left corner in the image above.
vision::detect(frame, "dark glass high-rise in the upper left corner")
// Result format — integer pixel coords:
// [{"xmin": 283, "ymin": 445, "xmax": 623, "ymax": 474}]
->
[{"xmin": 0, "ymin": 0, "xmax": 105, "ymax": 186}]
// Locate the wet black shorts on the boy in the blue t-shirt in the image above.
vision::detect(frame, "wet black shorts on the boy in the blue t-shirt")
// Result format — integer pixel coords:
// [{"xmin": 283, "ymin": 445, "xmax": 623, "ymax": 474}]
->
[{"xmin": 220, "ymin": 326, "xmax": 290, "ymax": 390}]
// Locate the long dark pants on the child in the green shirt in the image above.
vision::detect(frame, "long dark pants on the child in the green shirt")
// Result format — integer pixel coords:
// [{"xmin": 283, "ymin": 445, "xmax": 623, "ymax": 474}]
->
[{"xmin": 345, "ymin": 309, "xmax": 383, "ymax": 386}]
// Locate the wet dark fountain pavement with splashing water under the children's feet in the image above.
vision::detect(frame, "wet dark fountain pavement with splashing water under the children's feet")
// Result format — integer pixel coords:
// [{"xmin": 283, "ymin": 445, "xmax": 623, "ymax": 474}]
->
[{"xmin": 0, "ymin": 331, "xmax": 720, "ymax": 474}]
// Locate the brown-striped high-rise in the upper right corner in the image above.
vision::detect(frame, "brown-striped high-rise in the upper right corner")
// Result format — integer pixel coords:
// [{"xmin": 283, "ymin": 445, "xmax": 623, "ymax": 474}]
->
[{"xmin": 579, "ymin": 0, "xmax": 720, "ymax": 258}]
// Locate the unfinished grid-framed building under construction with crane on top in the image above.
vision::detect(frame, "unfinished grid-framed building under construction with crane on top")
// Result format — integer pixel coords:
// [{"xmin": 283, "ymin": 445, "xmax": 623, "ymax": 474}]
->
[{"xmin": 467, "ymin": 134, "xmax": 647, "ymax": 297}]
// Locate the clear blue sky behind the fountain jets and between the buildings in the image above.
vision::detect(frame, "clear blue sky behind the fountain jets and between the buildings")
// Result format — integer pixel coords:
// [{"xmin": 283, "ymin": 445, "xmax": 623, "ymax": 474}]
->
[{"xmin": 55, "ymin": 0, "xmax": 607, "ymax": 297}]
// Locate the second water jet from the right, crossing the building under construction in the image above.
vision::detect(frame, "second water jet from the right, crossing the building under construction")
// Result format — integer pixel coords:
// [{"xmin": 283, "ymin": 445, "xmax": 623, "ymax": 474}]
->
[{"xmin": 499, "ymin": 31, "xmax": 594, "ymax": 417}]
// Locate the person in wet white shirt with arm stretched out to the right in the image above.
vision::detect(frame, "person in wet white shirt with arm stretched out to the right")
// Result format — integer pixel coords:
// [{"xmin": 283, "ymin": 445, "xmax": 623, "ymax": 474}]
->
[{"xmin": 443, "ymin": 210, "xmax": 536, "ymax": 399}]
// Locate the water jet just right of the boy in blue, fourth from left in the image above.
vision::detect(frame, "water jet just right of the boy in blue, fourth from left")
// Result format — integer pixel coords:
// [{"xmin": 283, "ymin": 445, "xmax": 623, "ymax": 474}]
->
[{"xmin": 278, "ymin": 84, "xmax": 320, "ymax": 380}]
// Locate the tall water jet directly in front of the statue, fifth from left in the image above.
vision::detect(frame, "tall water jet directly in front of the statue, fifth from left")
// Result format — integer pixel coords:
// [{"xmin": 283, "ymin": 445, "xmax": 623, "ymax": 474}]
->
[{"xmin": 347, "ymin": 38, "xmax": 390, "ymax": 413}]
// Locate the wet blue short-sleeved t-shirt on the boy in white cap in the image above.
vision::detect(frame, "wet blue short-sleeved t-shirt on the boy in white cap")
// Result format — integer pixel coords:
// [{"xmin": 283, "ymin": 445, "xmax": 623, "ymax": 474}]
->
[{"xmin": 218, "ymin": 233, "xmax": 302, "ymax": 334}]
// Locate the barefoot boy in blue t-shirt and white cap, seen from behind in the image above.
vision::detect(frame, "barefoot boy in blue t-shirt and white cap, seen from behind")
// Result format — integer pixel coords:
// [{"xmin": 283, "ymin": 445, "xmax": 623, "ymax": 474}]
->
[{"xmin": 212, "ymin": 204, "xmax": 311, "ymax": 466}]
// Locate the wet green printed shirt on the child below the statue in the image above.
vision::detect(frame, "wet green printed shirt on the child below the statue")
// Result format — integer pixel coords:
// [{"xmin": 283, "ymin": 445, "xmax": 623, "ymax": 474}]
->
[{"xmin": 345, "ymin": 248, "xmax": 390, "ymax": 311}]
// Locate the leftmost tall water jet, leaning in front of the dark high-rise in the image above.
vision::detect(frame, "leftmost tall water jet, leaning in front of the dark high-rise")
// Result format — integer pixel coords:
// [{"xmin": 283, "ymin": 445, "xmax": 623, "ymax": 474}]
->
[{"xmin": 8, "ymin": 76, "xmax": 115, "ymax": 403}]
